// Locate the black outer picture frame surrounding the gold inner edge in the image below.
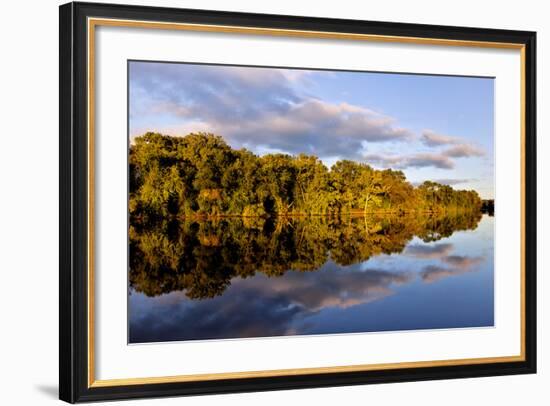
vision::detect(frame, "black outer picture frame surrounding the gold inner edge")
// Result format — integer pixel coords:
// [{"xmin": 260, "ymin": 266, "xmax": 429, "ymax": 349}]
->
[{"xmin": 59, "ymin": 3, "xmax": 536, "ymax": 403}]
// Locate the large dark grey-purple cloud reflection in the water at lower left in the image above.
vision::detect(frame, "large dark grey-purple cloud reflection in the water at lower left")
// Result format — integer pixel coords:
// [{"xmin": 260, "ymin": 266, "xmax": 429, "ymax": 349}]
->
[{"xmin": 130, "ymin": 263, "xmax": 414, "ymax": 343}]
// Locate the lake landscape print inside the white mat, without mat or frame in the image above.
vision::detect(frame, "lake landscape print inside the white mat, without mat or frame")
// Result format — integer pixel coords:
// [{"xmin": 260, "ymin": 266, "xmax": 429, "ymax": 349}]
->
[{"xmin": 128, "ymin": 60, "xmax": 495, "ymax": 344}]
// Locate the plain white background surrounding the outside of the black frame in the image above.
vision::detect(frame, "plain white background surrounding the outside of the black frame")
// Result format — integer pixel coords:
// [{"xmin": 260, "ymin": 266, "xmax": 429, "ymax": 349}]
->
[{"xmin": 0, "ymin": 0, "xmax": 550, "ymax": 406}]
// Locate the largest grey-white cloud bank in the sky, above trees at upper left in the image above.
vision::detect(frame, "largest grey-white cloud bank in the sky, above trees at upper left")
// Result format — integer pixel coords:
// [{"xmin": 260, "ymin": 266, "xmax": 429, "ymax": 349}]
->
[{"xmin": 130, "ymin": 63, "xmax": 414, "ymax": 159}]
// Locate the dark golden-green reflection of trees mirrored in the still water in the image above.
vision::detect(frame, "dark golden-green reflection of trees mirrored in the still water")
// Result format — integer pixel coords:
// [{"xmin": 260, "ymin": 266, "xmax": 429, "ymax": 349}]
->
[{"xmin": 130, "ymin": 212, "xmax": 481, "ymax": 299}]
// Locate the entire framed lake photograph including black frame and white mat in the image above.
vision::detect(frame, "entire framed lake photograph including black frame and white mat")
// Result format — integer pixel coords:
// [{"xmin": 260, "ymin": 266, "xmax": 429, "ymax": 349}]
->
[{"xmin": 60, "ymin": 3, "xmax": 536, "ymax": 402}]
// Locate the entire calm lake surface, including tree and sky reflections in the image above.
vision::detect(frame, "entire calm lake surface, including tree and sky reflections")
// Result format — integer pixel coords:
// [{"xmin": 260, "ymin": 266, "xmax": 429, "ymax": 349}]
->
[{"xmin": 128, "ymin": 213, "xmax": 494, "ymax": 343}]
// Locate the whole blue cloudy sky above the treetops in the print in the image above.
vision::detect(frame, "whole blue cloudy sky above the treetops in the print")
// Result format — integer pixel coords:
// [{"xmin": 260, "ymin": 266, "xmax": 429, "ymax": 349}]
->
[{"xmin": 128, "ymin": 61, "xmax": 494, "ymax": 199}]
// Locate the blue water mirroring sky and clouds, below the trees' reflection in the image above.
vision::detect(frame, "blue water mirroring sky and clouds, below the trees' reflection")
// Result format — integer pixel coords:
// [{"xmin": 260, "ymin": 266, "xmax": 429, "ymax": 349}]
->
[{"xmin": 129, "ymin": 216, "xmax": 494, "ymax": 343}]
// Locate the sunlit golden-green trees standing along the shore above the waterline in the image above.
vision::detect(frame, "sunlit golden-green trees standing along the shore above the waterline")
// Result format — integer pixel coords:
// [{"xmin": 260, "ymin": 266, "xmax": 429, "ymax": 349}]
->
[{"xmin": 129, "ymin": 133, "xmax": 482, "ymax": 220}]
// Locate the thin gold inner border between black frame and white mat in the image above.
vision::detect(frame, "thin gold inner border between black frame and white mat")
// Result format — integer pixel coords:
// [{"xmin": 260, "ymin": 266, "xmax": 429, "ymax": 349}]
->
[{"xmin": 87, "ymin": 18, "xmax": 526, "ymax": 388}]
